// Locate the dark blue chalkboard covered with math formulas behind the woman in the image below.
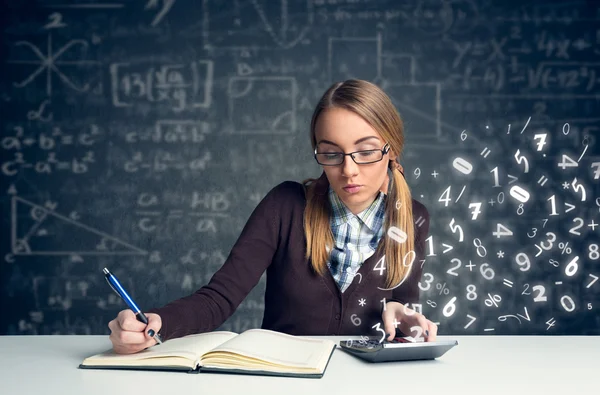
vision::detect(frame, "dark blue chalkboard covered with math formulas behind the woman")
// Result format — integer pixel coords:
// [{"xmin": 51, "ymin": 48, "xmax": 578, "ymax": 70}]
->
[{"xmin": 0, "ymin": 0, "xmax": 600, "ymax": 335}]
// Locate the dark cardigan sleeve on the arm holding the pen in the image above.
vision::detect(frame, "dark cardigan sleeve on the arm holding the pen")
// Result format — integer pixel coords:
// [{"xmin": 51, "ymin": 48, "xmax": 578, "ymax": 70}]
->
[{"xmin": 147, "ymin": 184, "xmax": 282, "ymax": 340}]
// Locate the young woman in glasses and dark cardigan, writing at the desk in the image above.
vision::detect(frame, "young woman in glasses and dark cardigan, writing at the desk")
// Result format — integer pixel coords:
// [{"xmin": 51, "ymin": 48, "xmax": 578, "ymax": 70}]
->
[{"xmin": 108, "ymin": 80, "xmax": 437, "ymax": 353}]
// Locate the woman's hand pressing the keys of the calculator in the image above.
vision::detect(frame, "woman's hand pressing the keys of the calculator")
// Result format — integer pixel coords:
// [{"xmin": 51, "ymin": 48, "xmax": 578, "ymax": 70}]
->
[{"xmin": 382, "ymin": 302, "xmax": 437, "ymax": 342}]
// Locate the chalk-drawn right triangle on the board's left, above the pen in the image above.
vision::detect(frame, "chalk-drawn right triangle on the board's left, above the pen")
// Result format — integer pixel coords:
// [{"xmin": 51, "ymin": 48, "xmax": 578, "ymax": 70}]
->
[{"xmin": 11, "ymin": 196, "xmax": 147, "ymax": 255}]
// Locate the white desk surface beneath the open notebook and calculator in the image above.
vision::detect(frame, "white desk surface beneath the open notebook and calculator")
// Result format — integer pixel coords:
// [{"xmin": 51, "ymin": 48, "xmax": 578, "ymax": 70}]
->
[{"xmin": 0, "ymin": 335, "xmax": 600, "ymax": 395}]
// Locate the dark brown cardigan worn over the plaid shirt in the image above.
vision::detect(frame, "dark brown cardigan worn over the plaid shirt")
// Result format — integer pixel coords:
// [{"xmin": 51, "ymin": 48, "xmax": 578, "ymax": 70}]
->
[{"xmin": 148, "ymin": 181, "xmax": 429, "ymax": 340}]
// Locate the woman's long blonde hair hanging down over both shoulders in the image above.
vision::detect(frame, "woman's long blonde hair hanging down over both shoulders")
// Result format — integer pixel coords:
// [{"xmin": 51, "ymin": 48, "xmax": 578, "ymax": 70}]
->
[{"xmin": 302, "ymin": 79, "xmax": 415, "ymax": 287}]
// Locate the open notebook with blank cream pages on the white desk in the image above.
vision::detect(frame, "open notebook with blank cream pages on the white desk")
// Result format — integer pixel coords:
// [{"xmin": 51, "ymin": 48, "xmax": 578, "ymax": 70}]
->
[{"xmin": 79, "ymin": 329, "xmax": 336, "ymax": 378}]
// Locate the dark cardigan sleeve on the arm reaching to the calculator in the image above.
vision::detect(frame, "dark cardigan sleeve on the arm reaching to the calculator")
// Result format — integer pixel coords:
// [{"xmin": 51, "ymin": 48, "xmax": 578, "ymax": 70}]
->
[{"xmin": 388, "ymin": 200, "xmax": 429, "ymax": 304}]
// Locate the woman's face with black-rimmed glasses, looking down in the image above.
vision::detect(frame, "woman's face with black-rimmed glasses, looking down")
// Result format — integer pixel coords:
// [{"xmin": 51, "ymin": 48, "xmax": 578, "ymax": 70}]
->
[{"xmin": 315, "ymin": 108, "xmax": 395, "ymax": 214}]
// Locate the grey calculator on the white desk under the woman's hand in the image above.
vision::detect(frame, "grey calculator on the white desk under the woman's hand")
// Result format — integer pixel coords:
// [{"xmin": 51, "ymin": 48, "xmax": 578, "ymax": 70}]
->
[{"xmin": 340, "ymin": 336, "xmax": 458, "ymax": 362}]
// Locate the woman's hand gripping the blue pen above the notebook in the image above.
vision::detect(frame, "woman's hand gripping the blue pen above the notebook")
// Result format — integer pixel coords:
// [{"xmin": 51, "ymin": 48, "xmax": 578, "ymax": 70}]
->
[{"xmin": 108, "ymin": 309, "xmax": 162, "ymax": 354}]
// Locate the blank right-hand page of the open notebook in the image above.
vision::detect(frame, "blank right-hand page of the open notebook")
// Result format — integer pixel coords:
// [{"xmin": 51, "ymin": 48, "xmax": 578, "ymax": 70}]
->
[{"xmin": 206, "ymin": 329, "xmax": 335, "ymax": 368}]
